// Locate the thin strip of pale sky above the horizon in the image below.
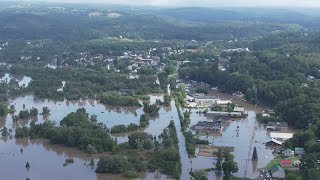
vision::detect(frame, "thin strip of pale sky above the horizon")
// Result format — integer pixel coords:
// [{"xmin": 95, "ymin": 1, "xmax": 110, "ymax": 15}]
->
[{"xmin": 13, "ymin": 0, "xmax": 320, "ymax": 7}]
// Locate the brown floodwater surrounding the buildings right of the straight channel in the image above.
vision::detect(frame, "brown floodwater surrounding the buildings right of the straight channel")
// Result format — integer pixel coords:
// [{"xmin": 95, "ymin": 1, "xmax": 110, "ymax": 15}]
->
[{"xmin": 190, "ymin": 110, "xmax": 274, "ymax": 179}]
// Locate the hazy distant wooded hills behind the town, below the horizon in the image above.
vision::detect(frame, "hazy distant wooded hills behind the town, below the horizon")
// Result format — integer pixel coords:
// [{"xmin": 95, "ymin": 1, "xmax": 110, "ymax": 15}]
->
[{"xmin": 0, "ymin": 9, "xmax": 293, "ymax": 43}]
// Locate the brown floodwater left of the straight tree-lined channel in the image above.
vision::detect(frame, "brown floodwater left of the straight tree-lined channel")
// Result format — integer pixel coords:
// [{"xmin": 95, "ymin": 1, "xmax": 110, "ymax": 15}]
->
[{"xmin": 0, "ymin": 95, "xmax": 180, "ymax": 180}]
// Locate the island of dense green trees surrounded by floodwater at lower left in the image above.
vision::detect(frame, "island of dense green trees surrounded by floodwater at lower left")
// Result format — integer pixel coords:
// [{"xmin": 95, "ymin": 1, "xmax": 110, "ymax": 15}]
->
[{"xmin": 15, "ymin": 108, "xmax": 117, "ymax": 153}]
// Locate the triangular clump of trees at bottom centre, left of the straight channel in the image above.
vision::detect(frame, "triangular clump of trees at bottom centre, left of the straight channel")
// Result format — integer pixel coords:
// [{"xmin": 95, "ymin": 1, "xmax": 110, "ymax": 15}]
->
[{"xmin": 96, "ymin": 121, "xmax": 181, "ymax": 179}]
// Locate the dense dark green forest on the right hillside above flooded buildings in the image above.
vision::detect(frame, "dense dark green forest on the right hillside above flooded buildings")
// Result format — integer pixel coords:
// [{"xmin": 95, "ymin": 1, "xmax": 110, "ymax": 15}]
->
[{"xmin": 179, "ymin": 32, "xmax": 320, "ymax": 179}]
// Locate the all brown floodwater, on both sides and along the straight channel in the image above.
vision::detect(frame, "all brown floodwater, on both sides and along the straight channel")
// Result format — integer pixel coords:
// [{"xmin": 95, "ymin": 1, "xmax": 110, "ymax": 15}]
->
[{"xmin": 0, "ymin": 90, "xmax": 273, "ymax": 180}]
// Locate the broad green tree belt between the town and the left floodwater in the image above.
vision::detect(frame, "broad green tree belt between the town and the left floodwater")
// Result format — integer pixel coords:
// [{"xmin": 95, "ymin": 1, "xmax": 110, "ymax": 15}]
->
[{"xmin": 7, "ymin": 64, "xmax": 159, "ymax": 102}]
